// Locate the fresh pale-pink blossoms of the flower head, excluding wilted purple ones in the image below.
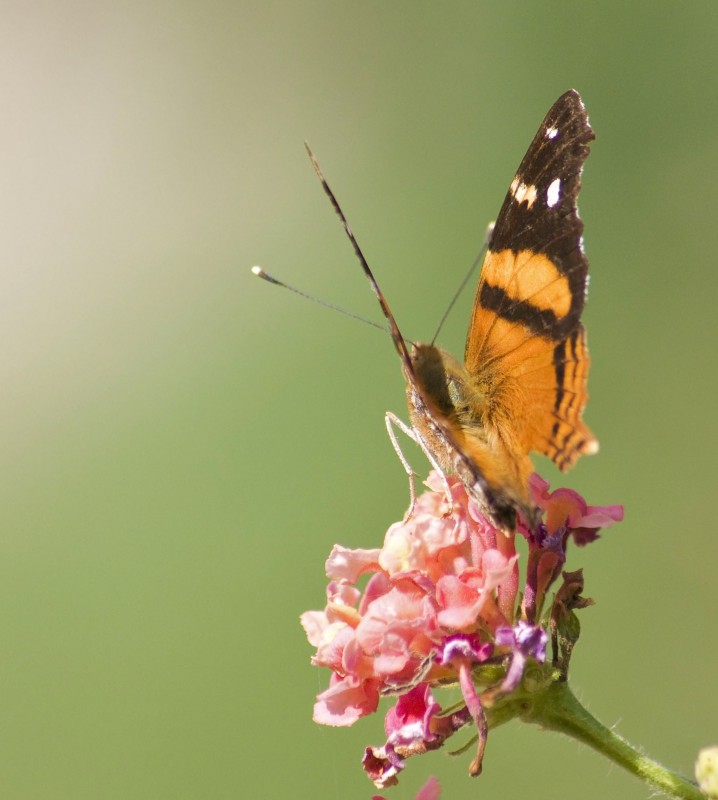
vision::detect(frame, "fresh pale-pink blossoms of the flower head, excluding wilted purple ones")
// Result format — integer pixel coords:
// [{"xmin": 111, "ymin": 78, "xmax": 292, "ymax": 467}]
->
[{"xmin": 302, "ymin": 474, "xmax": 518, "ymax": 725}]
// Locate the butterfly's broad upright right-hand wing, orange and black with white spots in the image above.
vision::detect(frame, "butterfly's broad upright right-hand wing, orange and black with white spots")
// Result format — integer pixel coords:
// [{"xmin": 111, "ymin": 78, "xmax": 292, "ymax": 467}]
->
[{"xmin": 465, "ymin": 91, "xmax": 597, "ymax": 469}]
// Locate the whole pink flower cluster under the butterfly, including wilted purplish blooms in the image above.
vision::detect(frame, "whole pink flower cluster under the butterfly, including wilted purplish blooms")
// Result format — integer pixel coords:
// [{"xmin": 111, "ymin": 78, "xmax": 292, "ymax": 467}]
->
[{"xmin": 302, "ymin": 472, "xmax": 623, "ymax": 787}]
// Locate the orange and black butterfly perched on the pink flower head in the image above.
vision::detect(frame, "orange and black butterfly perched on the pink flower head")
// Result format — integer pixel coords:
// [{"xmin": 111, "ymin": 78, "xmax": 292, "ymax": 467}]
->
[{"xmin": 300, "ymin": 90, "xmax": 598, "ymax": 531}]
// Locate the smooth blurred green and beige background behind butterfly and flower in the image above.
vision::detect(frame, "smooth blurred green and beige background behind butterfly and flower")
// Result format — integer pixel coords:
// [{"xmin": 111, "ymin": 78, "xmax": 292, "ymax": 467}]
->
[{"xmin": 0, "ymin": 0, "xmax": 718, "ymax": 800}]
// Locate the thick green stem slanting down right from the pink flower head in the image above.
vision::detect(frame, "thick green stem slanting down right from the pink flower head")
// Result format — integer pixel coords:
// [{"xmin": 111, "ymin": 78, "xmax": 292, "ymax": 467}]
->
[{"xmin": 521, "ymin": 682, "xmax": 706, "ymax": 800}]
